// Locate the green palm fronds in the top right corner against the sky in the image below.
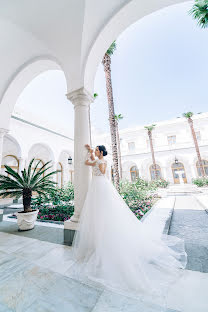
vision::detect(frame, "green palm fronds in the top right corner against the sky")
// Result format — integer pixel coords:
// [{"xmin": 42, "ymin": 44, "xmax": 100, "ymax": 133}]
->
[{"xmin": 189, "ymin": 0, "xmax": 208, "ymax": 28}]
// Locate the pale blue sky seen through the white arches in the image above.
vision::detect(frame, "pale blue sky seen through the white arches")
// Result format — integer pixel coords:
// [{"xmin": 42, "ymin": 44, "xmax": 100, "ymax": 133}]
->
[{"xmin": 17, "ymin": 2, "xmax": 208, "ymax": 136}]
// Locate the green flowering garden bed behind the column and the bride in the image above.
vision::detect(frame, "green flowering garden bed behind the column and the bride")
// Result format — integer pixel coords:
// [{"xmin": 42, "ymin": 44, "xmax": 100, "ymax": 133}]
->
[{"xmin": 7, "ymin": 179, "xmax": 168, "ymax": 224}]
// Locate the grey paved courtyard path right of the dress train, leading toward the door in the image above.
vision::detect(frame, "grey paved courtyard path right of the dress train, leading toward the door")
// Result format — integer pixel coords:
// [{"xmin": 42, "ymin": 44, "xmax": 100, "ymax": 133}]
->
[{"xmin": 169, "ymin": 196, "xmax": 208, "ymax": 272}]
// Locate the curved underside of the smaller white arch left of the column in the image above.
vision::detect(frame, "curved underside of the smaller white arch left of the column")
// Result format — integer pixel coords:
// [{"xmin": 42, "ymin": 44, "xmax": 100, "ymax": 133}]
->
[{"xmin": 0, "ymin": 56, "xmax": 65, "ymax": 129}]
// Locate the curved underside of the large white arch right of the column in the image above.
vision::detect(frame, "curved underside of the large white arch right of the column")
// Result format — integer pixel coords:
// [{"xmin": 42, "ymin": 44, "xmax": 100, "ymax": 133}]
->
[{"xmin": 83, "ymin": 0, "xmax": 187, "ymax": 92}]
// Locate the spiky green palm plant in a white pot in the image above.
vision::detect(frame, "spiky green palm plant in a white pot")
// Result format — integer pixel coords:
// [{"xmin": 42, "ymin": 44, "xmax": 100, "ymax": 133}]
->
[{"xmin": 0, "ymin": 158, "xmax": 60, "ymax": 231}]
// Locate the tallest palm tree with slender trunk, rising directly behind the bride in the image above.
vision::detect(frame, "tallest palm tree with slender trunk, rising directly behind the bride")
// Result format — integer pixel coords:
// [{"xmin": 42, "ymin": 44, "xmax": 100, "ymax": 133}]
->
[{"xmin": 102, "ymin": 41, "xmax": 120, "ymax": 191}]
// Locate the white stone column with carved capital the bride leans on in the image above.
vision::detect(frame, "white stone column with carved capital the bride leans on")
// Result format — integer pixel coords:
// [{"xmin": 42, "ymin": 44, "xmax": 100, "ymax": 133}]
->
[{"xmin": 64, "ymin": 88, "xmax": 93, "ymax": 243}]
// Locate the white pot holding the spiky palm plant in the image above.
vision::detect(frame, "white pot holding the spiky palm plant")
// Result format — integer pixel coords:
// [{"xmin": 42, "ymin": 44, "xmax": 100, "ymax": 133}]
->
[{"xmin": 16, "ymin": 209, "xmax": 39, "ymax": 231}]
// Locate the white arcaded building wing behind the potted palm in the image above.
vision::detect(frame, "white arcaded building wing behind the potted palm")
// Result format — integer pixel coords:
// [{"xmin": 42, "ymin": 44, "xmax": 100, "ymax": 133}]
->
[{"xmin": 1, "ymin": 115, "xmax": 74, "ymax": 187}]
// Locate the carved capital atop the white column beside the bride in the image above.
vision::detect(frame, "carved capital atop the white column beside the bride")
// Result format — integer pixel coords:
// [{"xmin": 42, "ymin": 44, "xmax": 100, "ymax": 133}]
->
[{"xmin": 66, "ymin": 88, "xmax": 94, "ymax": 106}]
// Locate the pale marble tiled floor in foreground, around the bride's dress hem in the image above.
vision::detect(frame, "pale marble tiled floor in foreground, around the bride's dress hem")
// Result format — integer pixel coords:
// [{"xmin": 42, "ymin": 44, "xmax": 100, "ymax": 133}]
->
[{"xmin": 0, "ymin": 232, "xmax": 208, "ymax": 312}]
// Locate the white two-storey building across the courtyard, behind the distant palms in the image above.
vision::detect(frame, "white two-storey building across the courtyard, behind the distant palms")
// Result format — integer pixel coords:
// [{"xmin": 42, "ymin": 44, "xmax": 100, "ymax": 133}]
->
[{"xmin": 96, "ymin": 113, "xmax": 208, "ymax": 184}]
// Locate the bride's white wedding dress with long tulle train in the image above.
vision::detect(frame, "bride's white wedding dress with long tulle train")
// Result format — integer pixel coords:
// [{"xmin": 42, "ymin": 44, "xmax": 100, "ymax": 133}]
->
[{"xmin": 71, "ymin": 159, "xmax": 187, "ymax": 305}]
